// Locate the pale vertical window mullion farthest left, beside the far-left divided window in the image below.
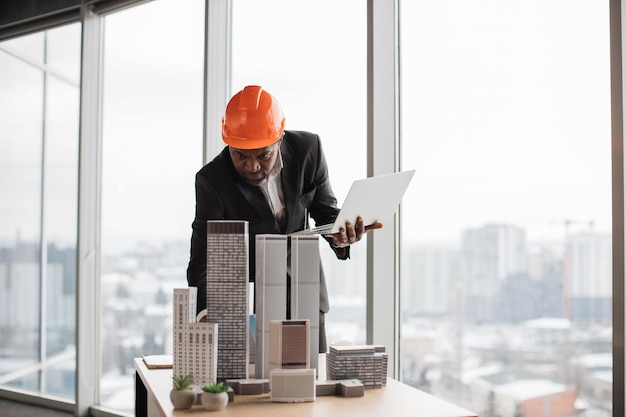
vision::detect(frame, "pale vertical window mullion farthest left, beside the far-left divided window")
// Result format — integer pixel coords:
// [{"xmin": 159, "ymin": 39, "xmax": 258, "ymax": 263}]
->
[{"xmin": 76, "ymin": 4, "xmax": 103, "ymax": 416}]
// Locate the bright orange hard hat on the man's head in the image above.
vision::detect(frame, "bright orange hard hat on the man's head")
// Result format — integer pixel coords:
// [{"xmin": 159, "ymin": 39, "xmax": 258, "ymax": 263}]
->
[{"xmin": 222, "ymin": 85, "xmax": 285, "ymax": 149}]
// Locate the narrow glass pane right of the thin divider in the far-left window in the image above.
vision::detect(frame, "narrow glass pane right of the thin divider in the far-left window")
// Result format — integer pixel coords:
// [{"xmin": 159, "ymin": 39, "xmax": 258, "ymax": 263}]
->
[{"xmin": 44, "ymin": 73, "xmax": 80, "ymax": 399}]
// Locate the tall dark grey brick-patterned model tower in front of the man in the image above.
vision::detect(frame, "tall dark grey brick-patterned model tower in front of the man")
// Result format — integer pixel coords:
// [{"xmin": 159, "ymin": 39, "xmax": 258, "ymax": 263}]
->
[{"xmin": 206, "ymin": 220, "xmax": 250, "ymax": 380}]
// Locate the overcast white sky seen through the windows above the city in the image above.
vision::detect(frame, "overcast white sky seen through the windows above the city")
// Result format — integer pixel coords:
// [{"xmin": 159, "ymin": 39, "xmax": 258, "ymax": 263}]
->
[{"xmin": 0, "ymin": 0, "xmax": 611, "ymax": 247}]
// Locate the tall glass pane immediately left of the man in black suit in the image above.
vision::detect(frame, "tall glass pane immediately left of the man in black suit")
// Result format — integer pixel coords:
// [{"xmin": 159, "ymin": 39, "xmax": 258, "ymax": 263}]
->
[{"xmin": 100, "ymin": 0, "xmax": 204, "ymax": 413}]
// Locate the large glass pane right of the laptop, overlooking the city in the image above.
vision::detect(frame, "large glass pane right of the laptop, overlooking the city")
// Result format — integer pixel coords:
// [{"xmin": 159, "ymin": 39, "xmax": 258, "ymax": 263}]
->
[{"xmin": 400, "ymin": 0, "xmax": 612, "ymax": 417}]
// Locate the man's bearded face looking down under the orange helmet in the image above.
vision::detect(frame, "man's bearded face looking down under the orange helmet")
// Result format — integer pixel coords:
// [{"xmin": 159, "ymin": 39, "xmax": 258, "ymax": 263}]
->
[{"xmin": 228, "ymin": 141, "xmax": 280, "ymax": 185}]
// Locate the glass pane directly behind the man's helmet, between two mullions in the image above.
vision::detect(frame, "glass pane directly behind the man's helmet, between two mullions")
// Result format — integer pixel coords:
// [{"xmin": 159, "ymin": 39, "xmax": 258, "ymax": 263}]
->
[{"xmin": 230, "ymin": 0, "xmax": 367, "ymax": 343}]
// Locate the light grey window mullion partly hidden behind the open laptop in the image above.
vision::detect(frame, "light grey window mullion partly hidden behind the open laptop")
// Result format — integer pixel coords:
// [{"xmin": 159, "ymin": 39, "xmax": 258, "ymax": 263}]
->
[{"xmin": 366, "ymin": 0, "xmax": 400, "ymax": 377}]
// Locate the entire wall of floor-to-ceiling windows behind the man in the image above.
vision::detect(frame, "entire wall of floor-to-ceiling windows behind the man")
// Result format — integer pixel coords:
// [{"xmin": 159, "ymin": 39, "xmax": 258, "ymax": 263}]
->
[{"xmin": 0, "ymin": 0, "xmax": 623, "ymax": 417}]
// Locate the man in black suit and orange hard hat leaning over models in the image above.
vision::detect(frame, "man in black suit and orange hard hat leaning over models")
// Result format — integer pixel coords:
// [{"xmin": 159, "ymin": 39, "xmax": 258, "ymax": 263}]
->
[{"xmin": 187, "ymin": 86, "xmax": 382, "ymax": 352}]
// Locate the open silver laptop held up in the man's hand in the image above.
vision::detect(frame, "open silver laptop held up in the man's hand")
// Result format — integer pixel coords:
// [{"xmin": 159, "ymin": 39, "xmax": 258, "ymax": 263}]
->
[{"xmin": 297, "ymin": 170, "xmax": 415, "ymax": 234}]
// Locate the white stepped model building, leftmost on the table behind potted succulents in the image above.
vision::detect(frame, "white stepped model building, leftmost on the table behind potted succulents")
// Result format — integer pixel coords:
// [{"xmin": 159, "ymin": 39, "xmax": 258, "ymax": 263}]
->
[{"xmin": 173, "ymin": 287, "xmax": 218, "ymax": 386}]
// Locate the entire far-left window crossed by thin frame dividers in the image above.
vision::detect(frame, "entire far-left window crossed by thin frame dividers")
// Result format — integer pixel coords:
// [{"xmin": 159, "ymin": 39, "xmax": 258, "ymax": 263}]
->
[{"xmin": 0, "ymin": 24, "xmax": 80, "ymax": 400}]
